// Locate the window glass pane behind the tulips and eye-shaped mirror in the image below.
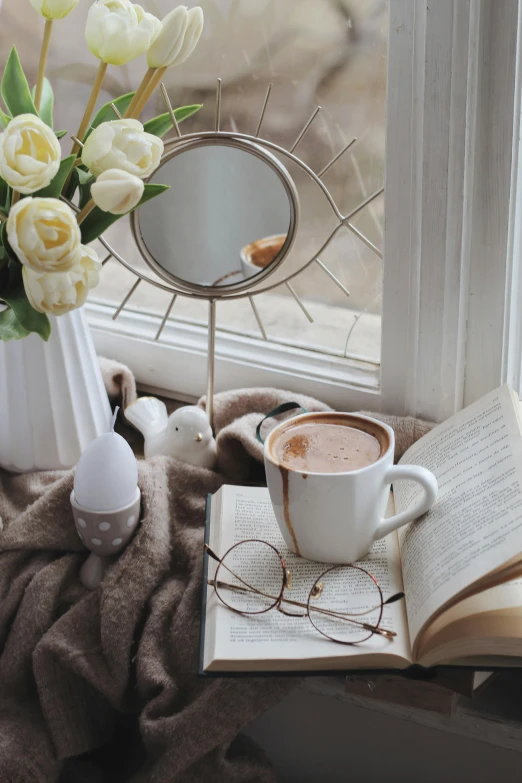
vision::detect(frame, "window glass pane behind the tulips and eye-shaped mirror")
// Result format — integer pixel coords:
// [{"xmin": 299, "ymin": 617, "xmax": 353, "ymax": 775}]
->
[{"xmin": 0, "ymin": 0, "xmax": 388, "ymax": 362}]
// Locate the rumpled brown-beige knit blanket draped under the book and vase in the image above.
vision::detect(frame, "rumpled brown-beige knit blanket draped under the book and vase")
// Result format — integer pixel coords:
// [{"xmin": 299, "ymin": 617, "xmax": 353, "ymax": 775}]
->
[{"xmin": 0, "ymin": 362, "xmax": 429, "ymax": 783}]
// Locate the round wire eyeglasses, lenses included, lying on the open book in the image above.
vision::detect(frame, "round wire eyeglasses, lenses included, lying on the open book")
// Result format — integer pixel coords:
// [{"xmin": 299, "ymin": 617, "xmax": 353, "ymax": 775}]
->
[{"xmin": 205, "ymin": 538, "xmax": 404, "ymax": 644}]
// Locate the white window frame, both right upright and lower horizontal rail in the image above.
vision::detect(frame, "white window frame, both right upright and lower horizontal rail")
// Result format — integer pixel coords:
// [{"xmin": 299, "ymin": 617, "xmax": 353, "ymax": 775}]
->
[{"xmin": 87, "ymin": 0, "xmax": 522, "ymax": 420}]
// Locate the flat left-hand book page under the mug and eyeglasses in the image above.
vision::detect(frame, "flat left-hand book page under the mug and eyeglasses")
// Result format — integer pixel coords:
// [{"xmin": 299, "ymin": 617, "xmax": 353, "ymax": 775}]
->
[{"xmin": 203, "ymin": 486, "xmax": 411, "ymax": 668}]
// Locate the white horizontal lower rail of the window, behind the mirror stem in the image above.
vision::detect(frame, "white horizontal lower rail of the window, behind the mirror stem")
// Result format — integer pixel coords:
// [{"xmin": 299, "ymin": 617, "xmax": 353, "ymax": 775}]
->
[{"xmin": 85, "ymin": 302, "xmax": 380, "ymax": 410}]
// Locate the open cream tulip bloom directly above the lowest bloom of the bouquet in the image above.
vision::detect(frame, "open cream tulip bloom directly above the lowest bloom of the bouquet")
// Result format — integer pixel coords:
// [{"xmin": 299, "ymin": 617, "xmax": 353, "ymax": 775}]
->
[{"xmin": 7, "ymin": 197, "xmax": 81, "ymax": 272}]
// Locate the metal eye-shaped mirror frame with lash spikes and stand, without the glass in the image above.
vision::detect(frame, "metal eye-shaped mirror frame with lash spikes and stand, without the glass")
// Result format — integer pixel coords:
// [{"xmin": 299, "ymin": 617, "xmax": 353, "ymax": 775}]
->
[{"xmin": 96, "ymin": 79, "xmax": 384, "ymax": 427}]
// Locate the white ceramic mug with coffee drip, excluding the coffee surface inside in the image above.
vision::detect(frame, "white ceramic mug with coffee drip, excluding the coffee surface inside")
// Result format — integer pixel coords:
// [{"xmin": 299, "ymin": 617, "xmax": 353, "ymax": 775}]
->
[{"xmin": 265, "ymin": 413, "xmax": 438, "ymax": 563}]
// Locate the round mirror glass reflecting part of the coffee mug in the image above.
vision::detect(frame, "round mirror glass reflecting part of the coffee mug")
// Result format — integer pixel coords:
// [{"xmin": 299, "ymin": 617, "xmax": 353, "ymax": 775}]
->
[{"xmin": 139, "ymin": 144, "xmax": 292, "ymax": 286}]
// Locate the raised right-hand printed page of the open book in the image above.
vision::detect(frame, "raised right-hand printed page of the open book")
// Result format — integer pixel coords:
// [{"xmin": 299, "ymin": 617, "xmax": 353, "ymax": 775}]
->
[{"xmin": 394, "ymin": 386, "xmax": 522, "ymax": 642}]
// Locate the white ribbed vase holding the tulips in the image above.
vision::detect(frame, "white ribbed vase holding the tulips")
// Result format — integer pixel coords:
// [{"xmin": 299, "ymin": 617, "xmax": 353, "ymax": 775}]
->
[{"xmin": 0, "ymin": 308, "xmax": 111, "ymax": 472}]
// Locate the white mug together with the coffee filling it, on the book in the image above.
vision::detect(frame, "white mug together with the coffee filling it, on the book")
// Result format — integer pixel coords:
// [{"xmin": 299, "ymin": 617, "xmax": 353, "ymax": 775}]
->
[{"xmin": 265, "ymin": 413, "xmax": 438, "ymax": 563}]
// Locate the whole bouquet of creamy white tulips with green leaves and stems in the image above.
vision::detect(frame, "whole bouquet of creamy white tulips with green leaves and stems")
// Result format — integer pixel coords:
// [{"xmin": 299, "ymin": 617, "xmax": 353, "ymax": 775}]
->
[{"xmin": 0, "ymin": 0, "xmax": 203, "ymax": 341}]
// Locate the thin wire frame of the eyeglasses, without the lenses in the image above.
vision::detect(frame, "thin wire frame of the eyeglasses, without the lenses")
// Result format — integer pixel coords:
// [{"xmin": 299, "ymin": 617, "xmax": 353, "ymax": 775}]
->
[{"xmin": 204, "ymin": 538, "xmax": 404, "ymax": 647}]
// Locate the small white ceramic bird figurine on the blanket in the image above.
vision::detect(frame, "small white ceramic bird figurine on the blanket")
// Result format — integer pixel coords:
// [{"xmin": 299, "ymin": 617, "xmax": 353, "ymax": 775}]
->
[{"xmin": 125, "ymin": 397, "xmax": 217, "ymax": 469}]
